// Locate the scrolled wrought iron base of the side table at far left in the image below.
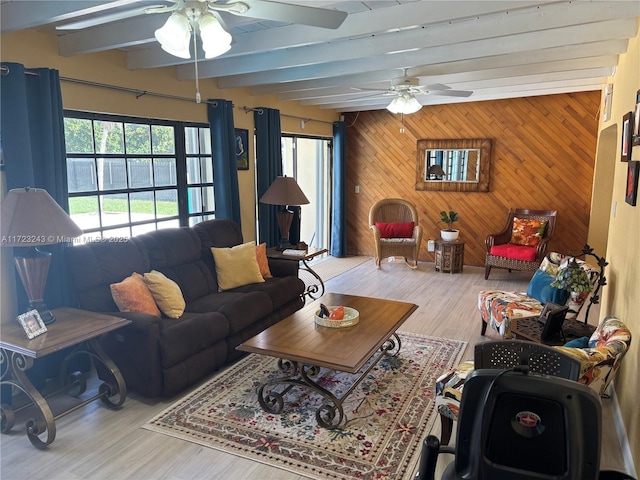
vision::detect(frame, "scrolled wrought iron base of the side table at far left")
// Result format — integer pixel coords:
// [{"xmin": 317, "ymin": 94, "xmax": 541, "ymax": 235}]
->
[{"xmin": 0, "ymin": 338, "xmax": 127, "ymax": 450}]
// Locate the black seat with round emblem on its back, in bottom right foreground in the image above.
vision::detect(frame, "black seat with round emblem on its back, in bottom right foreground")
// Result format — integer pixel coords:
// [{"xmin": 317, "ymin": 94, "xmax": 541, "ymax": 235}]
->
[{"xmin": 416, "ymin": 369, "xmax": 604, "ymax": 480}]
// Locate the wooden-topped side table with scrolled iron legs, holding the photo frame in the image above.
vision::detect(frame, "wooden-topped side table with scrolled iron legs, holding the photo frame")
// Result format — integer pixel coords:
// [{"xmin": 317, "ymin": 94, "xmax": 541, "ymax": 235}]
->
[{"xmin": 0, "ymin": 308, "xmax": 131, "ymax": 449}]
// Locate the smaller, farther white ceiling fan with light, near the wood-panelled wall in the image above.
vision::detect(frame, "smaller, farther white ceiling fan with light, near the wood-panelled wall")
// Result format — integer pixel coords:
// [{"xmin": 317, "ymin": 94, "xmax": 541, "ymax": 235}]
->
[{"xmin": 353, "ymin": 75, "xmax": 473, "ymax": 113}]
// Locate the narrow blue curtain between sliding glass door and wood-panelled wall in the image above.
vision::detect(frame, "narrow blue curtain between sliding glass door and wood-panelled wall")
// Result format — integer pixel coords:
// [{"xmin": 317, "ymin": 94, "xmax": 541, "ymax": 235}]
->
[{"xmin": 330, "ymin": 122, "xmax": 347, "ymax": 257}]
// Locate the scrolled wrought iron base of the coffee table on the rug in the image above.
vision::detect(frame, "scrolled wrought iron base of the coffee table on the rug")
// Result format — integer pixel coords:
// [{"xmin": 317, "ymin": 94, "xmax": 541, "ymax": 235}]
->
[{"xmin": 258, "ymin": 333, "xmax": 402, "ymax": 429}]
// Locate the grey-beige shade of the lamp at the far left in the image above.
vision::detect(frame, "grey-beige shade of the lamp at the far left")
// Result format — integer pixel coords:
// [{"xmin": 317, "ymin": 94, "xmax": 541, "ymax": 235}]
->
[{"xmin": 1, "ymin": 187, "xmax": 82, "ymax": 247}]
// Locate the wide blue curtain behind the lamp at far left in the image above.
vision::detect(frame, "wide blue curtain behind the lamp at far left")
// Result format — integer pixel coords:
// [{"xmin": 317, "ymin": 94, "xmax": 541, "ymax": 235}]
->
[{"xmin": 0, "ymin": 62, "xmax": 73, "ymax": 311}]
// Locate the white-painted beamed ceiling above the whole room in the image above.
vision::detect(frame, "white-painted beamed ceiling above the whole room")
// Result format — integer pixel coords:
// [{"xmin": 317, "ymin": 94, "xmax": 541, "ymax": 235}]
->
[{"xmin": 0, "ymin": 0, "xmax": 640, "ymax": 112}]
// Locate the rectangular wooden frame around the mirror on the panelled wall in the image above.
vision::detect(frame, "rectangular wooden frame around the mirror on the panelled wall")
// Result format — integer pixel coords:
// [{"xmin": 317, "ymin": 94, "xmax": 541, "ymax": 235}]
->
[{"xmin": 416, "ymin": 138, "xmax": 491, "ymax": 192}]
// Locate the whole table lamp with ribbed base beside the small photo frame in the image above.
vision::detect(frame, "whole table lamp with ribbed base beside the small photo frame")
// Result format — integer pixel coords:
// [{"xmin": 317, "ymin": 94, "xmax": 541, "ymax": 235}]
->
[{"xmin": 0, "ymin": 187, "xmax": 82, "ymax": 324}]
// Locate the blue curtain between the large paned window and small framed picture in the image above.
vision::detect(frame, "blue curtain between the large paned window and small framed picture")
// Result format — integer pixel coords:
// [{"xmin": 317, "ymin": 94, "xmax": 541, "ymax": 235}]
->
[{"xmin": 207, "ymin": 99, "xmax": 241, "ymax": 225}]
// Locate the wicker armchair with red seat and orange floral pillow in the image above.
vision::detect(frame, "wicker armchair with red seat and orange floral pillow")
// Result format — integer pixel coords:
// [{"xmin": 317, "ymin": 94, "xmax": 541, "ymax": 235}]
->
[{"xmin": 484, "ymin": 208, "xmax": 557, "ymax": 280}]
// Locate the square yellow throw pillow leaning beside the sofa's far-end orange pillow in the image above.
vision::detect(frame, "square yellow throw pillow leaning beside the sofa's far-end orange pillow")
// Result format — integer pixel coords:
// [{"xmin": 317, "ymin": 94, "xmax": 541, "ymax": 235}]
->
[{"xmin": 211, "ymin": 242, "xmax": 264, "ymax": 292}]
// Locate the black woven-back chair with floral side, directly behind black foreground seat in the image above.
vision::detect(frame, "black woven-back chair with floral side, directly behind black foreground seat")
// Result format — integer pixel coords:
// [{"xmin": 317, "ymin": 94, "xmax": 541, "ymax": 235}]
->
[{"xmin": 436, "ymin": 340, "xmax": 580, "ymax": 445}]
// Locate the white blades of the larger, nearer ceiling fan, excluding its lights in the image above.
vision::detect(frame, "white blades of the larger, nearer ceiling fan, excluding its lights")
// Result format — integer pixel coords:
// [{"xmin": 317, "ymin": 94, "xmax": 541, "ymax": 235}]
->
[{"xmin": 56, "ymin": 0, "xmax": 347, "ymax": 30}]
